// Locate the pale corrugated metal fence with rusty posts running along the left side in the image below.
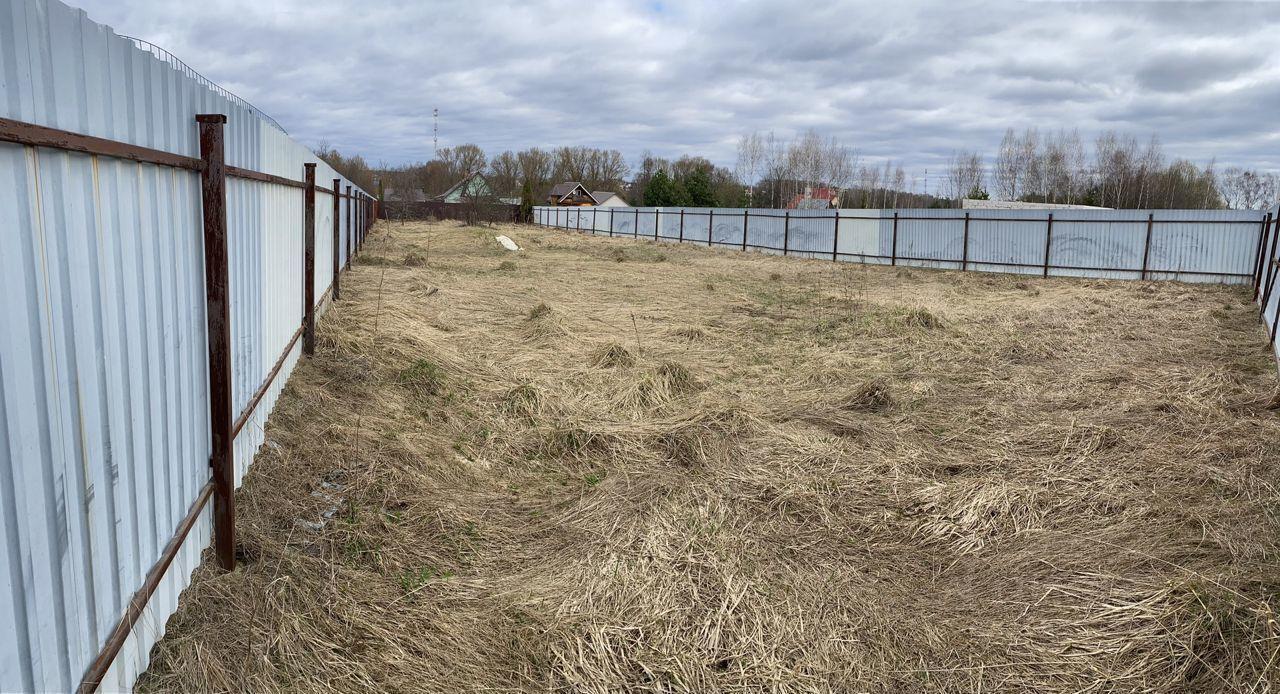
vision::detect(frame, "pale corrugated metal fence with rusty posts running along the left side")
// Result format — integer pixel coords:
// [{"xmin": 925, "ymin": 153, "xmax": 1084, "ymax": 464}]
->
[{"xmin": 0, "ymin": 0, "xmax": 376, "ymax": 691}]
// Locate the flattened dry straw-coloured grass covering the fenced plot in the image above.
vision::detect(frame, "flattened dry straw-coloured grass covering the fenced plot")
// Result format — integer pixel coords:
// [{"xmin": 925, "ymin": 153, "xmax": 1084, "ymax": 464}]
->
[{"xmin": 141, "ymin": 223, "xmax": 1280, "ymax": 693}]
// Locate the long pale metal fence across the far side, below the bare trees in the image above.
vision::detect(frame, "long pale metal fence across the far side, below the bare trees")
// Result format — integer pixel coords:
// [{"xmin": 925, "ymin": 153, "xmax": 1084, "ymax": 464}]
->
[{"xmin": 534, "ymin": 206, "xmax": 1268, "ymax": 284}]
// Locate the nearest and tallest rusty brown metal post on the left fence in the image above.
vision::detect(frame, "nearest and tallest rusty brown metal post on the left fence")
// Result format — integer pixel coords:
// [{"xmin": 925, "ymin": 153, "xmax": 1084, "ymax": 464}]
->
[{"xmin": 196, "ymin": 114, "xmax": 236, "ymax": 571}]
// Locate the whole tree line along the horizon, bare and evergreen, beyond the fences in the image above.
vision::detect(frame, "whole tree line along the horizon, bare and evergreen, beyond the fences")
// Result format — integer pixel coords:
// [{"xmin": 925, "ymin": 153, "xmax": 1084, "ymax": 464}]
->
[{"xmin": 316, "ymin": 128, "xmax": 1280, "ymax": 209}]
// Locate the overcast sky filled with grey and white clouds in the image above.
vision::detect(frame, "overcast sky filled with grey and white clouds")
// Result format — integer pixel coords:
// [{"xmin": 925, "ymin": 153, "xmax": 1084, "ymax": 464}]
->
[{"xmin": 70, "ymin": 0, "xmax": 1280, "ymax": 188}]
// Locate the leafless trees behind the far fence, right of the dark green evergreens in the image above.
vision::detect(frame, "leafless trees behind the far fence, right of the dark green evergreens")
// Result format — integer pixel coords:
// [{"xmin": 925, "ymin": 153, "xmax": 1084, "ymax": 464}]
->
[{"xmin": 737, "ymin": 128, "xmax": 1280, "ymax": 209}]
